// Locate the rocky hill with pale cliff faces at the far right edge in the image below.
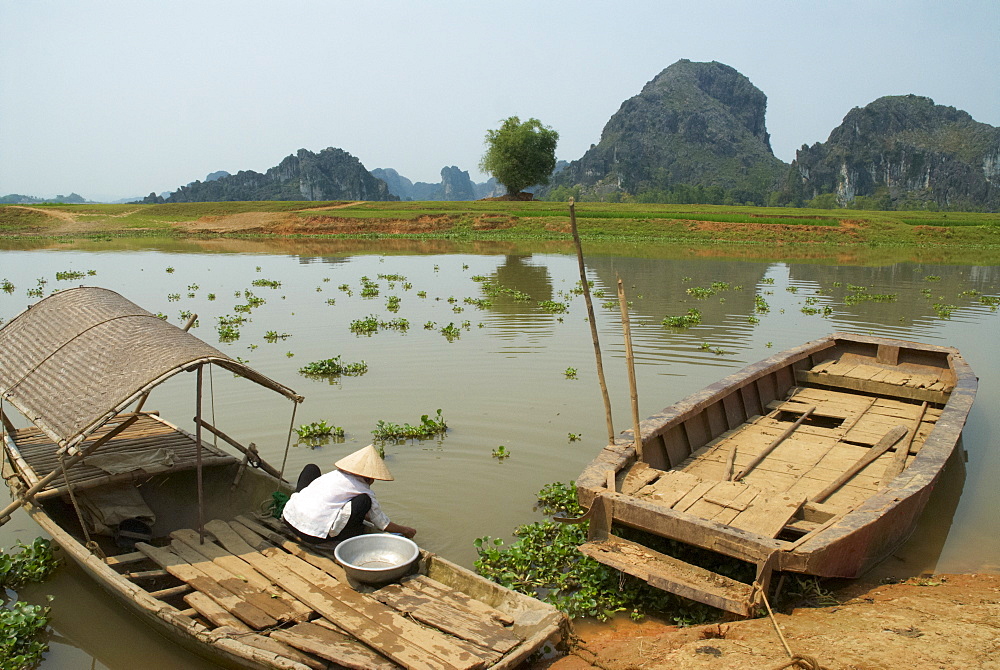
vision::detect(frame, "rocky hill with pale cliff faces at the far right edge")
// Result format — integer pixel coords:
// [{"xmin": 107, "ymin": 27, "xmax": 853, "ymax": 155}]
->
[{"xmin": 784, "ymin": 95, "xmax": 1000, "ymax": 211}]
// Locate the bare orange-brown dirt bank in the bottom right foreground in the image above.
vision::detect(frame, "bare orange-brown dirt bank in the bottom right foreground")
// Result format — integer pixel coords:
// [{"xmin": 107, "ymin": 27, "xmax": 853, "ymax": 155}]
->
[{"xmin": 535, "ymin": 575, "xmax": 1000, "ymax": 670}]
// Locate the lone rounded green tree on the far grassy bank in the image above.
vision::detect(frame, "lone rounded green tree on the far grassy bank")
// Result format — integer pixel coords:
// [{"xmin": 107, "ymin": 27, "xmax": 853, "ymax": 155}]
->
[{"xmin": 479, "ymin": 116, "xmax": 559, "ymax": 196}]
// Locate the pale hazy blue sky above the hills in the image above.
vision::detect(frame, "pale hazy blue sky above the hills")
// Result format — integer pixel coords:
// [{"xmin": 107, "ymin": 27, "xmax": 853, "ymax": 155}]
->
[{"xmin": 0, "ymin": 0, "xmax": 1000, "ymax": 200}]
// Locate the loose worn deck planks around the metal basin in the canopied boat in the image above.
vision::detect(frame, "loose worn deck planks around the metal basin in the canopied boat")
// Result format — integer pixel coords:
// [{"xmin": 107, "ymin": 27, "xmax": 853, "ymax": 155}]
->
[{"xmin": 114, "ymin": 517, "xmax": 525, "ymax": 670}]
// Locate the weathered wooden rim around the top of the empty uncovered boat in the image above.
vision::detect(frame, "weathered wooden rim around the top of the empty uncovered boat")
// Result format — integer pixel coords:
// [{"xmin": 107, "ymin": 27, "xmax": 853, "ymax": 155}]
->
[{"xmin": 577, "ymin": 332, "xmax": 978, "ymax": 569}]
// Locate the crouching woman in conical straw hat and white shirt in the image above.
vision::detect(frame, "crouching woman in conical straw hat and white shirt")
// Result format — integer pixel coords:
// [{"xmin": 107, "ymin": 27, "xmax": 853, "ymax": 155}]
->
[{"xmin": 281, "ymin": 444, "xmax": 417, "ymax": 544}]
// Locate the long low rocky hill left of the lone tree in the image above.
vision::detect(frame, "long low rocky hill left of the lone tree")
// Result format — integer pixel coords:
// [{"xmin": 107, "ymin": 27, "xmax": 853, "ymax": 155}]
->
[{"xmin": 159, "ymin": 147, "xmax": 398, "ymax": 202}]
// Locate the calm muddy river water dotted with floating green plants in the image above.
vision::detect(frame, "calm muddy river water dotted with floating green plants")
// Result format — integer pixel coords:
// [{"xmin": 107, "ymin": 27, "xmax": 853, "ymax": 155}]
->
[{"xmin": 0, "ymin": 240, "xmax": 1000, "ymax": 669}]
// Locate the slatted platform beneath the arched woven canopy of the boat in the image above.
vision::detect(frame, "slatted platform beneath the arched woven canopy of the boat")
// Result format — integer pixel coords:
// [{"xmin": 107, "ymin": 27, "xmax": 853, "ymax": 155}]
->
[{"xmin": 8, "ymin": 413, "xmax": 238, "ymax": 500}]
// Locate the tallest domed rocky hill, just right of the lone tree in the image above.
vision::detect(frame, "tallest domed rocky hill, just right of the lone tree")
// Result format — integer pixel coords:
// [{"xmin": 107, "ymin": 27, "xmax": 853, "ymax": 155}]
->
[{"xmin": 547, "ymin": 59, "xmax": 787, "ymax": 204}]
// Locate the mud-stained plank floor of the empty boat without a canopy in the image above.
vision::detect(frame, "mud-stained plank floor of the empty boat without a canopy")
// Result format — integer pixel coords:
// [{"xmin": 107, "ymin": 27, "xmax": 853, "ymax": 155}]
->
[{"xmin": 622, "ymin": 378, "xmax": 941, "ymax": 537}]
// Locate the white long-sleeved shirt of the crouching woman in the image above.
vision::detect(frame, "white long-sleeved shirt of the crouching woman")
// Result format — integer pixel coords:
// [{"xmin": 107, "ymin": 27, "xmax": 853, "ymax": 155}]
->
[{"xmin": 281, "ymin": 470, "xmax": 389, "ymax": 537}]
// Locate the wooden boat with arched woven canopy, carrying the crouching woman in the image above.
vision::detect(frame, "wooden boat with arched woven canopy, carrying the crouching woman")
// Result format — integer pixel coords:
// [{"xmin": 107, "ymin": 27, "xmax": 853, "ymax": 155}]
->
[{"xmin": 0, "ymin": 288, "xmax": 565, "ymax": 670}]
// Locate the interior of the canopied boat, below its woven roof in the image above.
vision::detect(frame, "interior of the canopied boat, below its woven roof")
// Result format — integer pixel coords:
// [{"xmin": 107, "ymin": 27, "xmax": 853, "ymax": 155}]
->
[{"xmin": 6, "ymin": 413, "xmax": 562, "ymax": 670}]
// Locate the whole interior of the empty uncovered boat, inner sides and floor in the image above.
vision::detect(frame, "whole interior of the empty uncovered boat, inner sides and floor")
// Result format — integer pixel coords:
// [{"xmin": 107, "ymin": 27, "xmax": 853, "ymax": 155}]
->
[{"xmin": 618, "ymin": 344, "xmax": 955, "ymax": 541}]
